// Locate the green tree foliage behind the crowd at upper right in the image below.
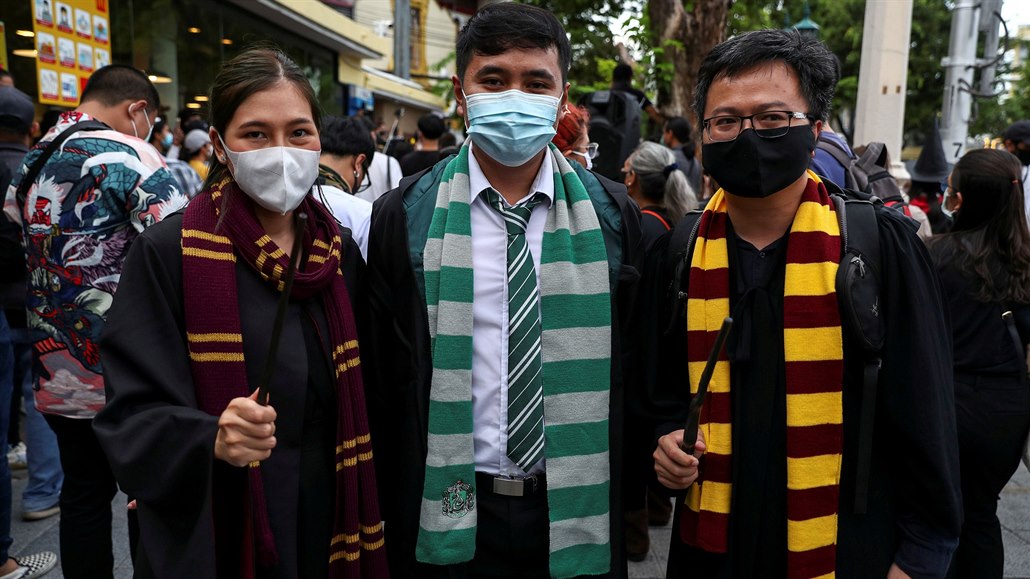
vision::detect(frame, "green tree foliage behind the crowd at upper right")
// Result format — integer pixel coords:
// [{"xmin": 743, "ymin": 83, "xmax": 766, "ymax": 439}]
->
[{"xmin": 543, "ymin": 0, "xmax": 1017, "ymax": 144}]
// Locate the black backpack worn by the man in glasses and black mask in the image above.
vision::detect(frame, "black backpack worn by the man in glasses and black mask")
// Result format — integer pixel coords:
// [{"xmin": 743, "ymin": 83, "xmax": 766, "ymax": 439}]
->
[{"xmin": 665, "ymin": 179, "xmax": 885, "ymax": 514}]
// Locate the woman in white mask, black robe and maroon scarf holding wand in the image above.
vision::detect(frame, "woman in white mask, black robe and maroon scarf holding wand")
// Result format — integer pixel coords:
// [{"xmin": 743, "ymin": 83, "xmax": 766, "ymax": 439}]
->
[{"xmin": 95, "ymin": 48, "xmax": 387, "ymax": 579}]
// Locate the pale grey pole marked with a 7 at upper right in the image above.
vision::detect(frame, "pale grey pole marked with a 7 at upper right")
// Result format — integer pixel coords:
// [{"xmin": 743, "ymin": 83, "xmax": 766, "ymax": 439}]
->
[{"xmin": 940, "ymin": 0, "xmax": 980, "ymax": 163}]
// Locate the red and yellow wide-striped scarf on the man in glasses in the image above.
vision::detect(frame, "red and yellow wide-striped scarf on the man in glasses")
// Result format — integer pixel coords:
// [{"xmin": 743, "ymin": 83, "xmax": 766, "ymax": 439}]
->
[{"xmin": 680, "ymin": 171, "xmax": 844, "ymax": 578}]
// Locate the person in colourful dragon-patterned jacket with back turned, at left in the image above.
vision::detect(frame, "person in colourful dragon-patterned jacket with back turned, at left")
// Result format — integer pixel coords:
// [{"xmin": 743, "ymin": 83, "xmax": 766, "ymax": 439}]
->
[{"xmin": 4, "ymin": 65, "xmax": 186, "ymax": 578}]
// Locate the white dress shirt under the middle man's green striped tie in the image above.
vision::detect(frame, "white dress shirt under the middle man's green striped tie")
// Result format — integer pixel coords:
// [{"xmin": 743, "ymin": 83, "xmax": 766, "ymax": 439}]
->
[{"xmin": 469, "ymin": 146, "xmax": 554, "ymax": 477}]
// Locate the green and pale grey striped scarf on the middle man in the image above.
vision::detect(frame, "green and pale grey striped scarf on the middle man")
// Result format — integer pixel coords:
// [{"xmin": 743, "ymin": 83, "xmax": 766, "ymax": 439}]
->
[{"xmin": 415, "ymin": 144, "xmax": 612, "ymax": 577}]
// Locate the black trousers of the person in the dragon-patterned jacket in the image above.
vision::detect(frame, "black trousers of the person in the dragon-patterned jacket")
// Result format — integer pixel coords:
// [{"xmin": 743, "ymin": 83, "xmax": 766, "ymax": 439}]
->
[{"xmin": 44, "ymin": 414, "xmax": 119, "ymax": 579}]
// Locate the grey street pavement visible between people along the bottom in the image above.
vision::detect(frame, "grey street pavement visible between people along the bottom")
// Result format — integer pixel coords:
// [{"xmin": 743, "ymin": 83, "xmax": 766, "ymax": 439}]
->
[{"xmin": 11, "ymin": 465, "xmax": 1030, "ymax": 579}]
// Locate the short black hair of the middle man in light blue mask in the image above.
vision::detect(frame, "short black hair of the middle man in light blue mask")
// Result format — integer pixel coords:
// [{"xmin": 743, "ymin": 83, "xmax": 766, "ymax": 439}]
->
[{"xmin": 456, "ymin": 2, "xmax": 573, "ymax": 84}]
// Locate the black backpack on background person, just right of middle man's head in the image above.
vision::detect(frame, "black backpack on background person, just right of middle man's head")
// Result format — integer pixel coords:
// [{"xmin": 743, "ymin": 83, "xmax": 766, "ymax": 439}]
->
[{"xmin": 580, "ymin": 91, "xmax": 641, "ymax": 183}]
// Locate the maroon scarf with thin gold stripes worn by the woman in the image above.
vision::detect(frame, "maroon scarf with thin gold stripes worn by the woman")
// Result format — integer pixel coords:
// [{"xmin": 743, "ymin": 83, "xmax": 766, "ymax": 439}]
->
[{"xmin": 182, "ymin": 178, "xmax": 388, "ymax": 578}]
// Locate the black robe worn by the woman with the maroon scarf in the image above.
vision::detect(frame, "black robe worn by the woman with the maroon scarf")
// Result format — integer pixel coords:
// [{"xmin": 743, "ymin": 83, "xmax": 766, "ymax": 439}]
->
[{"xmin": 94, "ymin": 213, "xmax": 364, "ymax": 579}]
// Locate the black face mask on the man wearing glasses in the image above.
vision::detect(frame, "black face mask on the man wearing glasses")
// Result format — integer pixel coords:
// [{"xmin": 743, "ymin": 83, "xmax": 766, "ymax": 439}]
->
[{"xmin": 701, "ymin": 125, "xmax": 816, "ymax": 198}]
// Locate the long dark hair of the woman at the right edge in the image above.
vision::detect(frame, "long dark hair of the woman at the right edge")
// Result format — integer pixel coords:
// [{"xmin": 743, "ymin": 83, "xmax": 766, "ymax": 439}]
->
[{"xmin": 933, "ymin": 148, "xmax": 1030, "ymax": 304}]
